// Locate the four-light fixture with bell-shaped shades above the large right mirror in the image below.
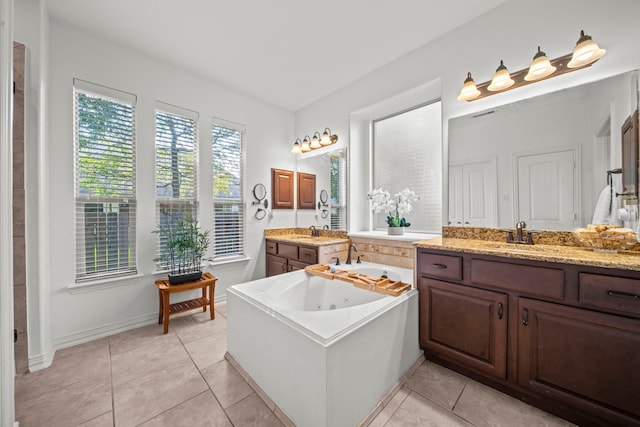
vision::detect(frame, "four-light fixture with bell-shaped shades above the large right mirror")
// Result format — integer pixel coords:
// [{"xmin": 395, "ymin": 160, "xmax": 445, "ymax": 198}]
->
[{"xmin": 458, "ymin": 31, "xmax": 606, "ymax": 101}]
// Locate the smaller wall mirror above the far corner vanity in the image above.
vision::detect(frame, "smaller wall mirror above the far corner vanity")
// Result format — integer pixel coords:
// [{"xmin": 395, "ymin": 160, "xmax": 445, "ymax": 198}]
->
[{"xmin": 296, "ymin": 148, "xmax": 348, "ymax": 230}]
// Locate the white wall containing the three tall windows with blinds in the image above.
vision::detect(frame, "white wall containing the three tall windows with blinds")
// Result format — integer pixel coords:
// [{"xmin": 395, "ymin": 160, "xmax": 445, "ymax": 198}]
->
[{"xmin": 48, "ymin": 20, "xmax": 295, "ymax": 348}]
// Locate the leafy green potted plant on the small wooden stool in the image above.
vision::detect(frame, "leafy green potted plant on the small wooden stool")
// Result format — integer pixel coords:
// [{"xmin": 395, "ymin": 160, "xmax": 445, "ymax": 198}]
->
[{"xmin": 154, "ymin": 216, "xmax": 210, "ymax": 285}]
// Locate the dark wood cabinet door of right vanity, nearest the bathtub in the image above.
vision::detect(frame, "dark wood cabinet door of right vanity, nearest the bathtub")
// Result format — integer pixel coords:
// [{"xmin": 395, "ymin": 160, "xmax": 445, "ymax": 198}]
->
[{"xmin": 418, "ymin": 278, "xmax": 508, "ymax": 379}]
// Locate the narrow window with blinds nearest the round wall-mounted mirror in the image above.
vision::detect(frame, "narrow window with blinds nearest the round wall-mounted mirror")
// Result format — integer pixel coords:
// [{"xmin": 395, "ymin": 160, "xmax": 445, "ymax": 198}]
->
[{"xmin": 212, "ymin": 121, "xmax": 244, "ymax": 260}]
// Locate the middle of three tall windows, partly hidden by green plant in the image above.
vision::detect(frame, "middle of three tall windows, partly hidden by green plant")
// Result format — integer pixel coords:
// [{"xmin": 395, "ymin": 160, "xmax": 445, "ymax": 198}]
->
[{"xmin": 156, "ymin": 103, "xmax": 198, "ymax": 270}]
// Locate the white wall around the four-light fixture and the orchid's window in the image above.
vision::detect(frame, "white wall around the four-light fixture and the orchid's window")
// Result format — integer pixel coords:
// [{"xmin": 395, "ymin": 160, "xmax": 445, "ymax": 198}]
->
[{"xmin": 296, "ymin": 0, "xmax": 640, "ymax": 231}]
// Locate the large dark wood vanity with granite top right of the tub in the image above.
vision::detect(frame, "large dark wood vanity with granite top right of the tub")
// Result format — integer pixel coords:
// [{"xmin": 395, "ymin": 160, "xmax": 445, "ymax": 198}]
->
[{"xmin": 415, "ymin": 231, "xmax": 640, "ymax": 425}]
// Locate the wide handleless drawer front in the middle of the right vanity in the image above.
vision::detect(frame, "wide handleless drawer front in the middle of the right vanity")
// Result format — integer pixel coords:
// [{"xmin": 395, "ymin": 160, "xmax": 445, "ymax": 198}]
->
[{"xmin": 471, "ymin": 259, "xmax": 564, "ymax": 301}]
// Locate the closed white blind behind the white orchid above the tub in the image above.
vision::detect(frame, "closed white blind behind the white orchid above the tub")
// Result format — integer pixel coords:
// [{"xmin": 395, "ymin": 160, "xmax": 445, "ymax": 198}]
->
[{"xmin": 372, "ymin": 101, "xmax": 442, "ymax": 232}]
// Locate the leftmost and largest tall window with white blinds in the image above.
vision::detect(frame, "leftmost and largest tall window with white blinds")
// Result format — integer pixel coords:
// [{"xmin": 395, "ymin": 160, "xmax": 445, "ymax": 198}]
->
[{"xmin": 74, "ymin": 80, "xmax": 136, "ymax": 282}]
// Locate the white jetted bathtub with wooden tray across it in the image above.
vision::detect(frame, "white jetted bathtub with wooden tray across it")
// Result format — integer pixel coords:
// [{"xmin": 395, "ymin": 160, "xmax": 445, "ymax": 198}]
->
[{"xmin": 227, "ymin": 263, "xmax": 422, "ymax": 426}]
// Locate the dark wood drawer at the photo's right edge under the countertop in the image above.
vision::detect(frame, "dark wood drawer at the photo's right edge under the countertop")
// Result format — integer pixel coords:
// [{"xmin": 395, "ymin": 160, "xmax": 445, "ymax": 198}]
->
[{"xmin": 579, "ymin": 273, "xmax": 640, "ymax": 316}]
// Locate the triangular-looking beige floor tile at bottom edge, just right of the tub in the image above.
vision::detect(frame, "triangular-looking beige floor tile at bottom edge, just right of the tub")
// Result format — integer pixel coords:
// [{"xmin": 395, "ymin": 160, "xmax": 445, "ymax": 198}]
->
[{"xmin": 385, "ymin": 392, "xmax": 473, "ymax": 427}]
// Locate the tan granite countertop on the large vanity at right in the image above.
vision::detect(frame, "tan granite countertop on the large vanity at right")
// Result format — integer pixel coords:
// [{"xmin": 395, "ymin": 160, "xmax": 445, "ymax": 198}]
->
[{"xmin": 415, "ymin": 237, "xmax": 640, "ymax": 271}]
